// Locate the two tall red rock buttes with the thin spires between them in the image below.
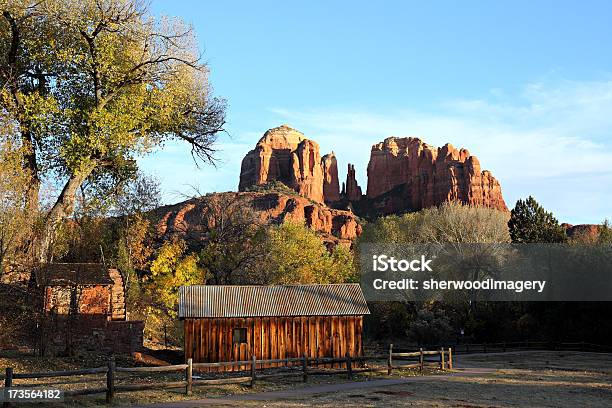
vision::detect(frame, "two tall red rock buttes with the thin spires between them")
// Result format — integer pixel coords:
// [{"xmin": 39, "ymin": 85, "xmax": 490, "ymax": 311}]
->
[{"xmin": 239, "ymin": 125, "xmax": 508, "ymax": 216}]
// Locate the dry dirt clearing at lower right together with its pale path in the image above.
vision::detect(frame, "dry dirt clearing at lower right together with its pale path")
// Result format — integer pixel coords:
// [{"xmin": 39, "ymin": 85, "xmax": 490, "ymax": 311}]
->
[{"xmin": 126, "ymin": 351, "xmax": 612, "ymax": 408}]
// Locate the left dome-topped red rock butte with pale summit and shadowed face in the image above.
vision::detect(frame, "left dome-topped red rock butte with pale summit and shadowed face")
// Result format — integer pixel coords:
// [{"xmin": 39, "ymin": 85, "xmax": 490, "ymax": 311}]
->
[{"xmin": 238, "ymin": 125, "xmax": 326, "ymax": 203}]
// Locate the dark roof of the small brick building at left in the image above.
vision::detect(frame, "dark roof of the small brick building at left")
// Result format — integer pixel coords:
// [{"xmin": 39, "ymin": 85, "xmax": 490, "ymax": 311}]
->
[{"xmin": 34, "ymin": 263, "xmax": 114, "ymax": 286}]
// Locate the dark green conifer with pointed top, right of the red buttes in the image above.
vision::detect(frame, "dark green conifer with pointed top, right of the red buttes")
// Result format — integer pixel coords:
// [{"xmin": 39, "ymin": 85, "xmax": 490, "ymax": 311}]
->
[{"xmin": 508, "ymin": 196, "xmax": 567, "ymax": 243}]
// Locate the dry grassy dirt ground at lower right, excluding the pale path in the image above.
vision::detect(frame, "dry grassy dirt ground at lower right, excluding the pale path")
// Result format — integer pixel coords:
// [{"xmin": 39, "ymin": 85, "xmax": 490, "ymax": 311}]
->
[{"xmin": 225, "ymin": 352, "xmax": 612, "ymax": 408}]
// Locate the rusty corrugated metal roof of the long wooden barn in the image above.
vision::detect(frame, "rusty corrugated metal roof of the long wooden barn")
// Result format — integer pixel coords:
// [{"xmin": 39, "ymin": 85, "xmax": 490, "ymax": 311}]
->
[{"xmin": 179, "ymin": 283, "xmax": 370, "ymax": 318}]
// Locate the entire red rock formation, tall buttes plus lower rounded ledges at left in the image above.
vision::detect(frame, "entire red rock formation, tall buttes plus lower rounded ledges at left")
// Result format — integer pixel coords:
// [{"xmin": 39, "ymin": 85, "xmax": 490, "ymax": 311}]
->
[{"xmin": 156, "ymin": 125, "xmax": 508, "ymax": 246}]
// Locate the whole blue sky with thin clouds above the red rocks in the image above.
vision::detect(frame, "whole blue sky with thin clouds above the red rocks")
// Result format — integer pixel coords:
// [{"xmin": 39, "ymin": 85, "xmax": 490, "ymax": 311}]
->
[{"xmin": 141, "ymin": 0, "xmax": 612, "ymax": 224}]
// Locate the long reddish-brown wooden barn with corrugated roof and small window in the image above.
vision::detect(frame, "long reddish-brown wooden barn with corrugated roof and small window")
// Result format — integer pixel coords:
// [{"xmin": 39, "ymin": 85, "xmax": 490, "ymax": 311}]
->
[{"xmin": 179, "ymin": 284, "xmax": 370, "ymax": 369}]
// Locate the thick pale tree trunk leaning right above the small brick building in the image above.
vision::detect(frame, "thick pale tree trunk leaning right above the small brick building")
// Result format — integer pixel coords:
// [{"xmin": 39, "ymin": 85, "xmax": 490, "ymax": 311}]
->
[{"xmin": 38, "ymin": 170, "xmax": 91, "ymax": 263}]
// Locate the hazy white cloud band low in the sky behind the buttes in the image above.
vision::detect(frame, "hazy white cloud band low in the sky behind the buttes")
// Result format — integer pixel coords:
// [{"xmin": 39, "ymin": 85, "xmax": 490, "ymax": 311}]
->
[{"xmin": 272, "ymin": 81, "xmax": 612, "ymax": 223}]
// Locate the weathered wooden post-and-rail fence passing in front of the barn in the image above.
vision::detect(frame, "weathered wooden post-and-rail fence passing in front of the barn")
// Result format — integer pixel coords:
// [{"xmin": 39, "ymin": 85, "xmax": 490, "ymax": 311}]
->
[{"xmin": 4, "ymin": 345, "xmax": 453, "ymax": 407}]
